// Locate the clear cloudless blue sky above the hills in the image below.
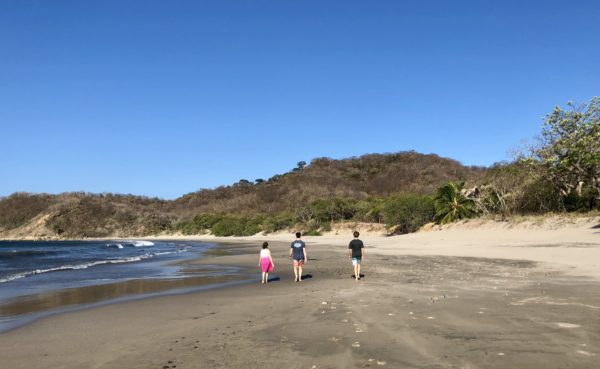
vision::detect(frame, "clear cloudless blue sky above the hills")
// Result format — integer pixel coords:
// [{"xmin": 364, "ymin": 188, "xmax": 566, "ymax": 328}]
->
[{"xmin": 0, "ymin": 0, "xmax": 600, "ymax": 198}]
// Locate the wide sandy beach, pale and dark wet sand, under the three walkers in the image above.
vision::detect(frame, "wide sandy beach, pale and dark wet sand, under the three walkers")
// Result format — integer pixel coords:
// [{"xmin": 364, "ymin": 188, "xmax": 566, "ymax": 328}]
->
[{"xmin": 0, "ymin": 218, "xmax": 600, "ymax": 369}]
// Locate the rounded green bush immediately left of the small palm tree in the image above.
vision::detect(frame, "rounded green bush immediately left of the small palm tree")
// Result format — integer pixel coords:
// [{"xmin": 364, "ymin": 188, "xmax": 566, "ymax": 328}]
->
[{"xmin": 382, "ymin": 193, "xmax": 435, "ymax": 233}]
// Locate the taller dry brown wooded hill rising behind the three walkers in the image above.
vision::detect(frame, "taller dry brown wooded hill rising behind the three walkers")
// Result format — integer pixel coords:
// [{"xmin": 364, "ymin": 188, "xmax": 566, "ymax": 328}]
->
[{"xmin": 175, "ymin": 152, "xmax": 485, "ymax": 214}]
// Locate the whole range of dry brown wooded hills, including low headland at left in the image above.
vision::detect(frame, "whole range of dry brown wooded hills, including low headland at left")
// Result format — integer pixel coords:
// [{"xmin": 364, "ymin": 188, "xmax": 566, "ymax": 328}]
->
[{"xmin": 0, "ymin": 152, "xmax": 487, "ymax": 238}]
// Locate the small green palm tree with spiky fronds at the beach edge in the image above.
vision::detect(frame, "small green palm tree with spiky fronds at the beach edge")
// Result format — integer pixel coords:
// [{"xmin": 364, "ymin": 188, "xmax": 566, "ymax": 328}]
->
[{"xmin": 434, "ymin": 182, "xmax": 475, "ymax": 224}]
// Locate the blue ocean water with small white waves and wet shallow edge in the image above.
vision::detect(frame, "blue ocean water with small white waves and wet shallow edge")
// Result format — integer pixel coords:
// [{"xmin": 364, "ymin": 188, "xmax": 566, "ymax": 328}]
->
[{"xmin": 0, "ymin": 240, "xmax": 236, "ymax": 332}]
